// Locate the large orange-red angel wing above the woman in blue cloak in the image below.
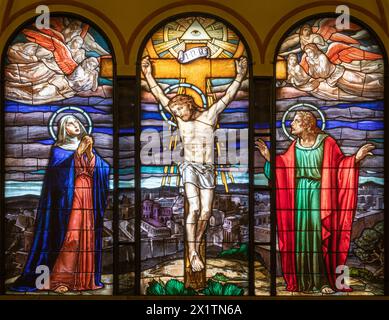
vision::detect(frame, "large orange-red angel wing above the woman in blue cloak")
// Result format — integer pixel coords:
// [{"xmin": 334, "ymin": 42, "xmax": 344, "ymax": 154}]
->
[{"xmin": 23, "ymin": 29, "xmax": 78, "ymax": 75}]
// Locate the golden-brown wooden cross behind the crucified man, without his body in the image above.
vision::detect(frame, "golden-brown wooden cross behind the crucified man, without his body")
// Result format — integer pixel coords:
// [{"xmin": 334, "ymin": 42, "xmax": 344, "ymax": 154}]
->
[{"xmin": 141, "ymin": 48, "xmax": 236, "ymax": 289}]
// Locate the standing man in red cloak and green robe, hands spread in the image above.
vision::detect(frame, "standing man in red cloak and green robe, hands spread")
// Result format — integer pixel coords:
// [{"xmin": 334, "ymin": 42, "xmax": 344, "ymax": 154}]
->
[{"xmin": 256, "ymin": 111, "xmax": 375, "ymax": 294}]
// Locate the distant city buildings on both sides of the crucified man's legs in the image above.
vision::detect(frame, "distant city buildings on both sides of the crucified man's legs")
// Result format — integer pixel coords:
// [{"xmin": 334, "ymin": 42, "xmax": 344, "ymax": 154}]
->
[{"xmin": 141, "ymin": 194, "xmax": 249, "ymax": 258}]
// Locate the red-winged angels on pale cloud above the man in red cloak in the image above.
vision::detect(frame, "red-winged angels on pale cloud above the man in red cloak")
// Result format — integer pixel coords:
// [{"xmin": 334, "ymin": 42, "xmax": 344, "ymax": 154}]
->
[{"xmin": 279, "ymin": 19, "xmax": 383, "ymax": 101}]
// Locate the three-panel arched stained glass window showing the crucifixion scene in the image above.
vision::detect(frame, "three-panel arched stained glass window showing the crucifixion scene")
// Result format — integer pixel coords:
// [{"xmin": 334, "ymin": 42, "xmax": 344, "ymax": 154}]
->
[{"xmin": 1, "ymin": 15, "xmax": 385, "ymax": 296}]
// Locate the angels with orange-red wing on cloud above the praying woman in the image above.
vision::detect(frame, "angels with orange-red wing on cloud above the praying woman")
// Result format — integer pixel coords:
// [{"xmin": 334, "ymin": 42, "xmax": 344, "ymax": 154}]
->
[{"xmin": 5, "ymin": 18, "xmax": 109, "ymax": 104}]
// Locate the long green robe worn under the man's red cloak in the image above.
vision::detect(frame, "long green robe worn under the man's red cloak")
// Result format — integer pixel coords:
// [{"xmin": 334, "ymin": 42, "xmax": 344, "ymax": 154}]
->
[{"xmin": 265, "ymin": 134, "xmax": 328, "ymax": 291}]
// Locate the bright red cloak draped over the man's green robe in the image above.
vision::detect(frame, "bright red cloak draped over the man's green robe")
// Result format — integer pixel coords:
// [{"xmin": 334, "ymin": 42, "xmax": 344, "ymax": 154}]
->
[{"xmin": 276, "ymin": 137, "xmax": 359, "ymax": 291}]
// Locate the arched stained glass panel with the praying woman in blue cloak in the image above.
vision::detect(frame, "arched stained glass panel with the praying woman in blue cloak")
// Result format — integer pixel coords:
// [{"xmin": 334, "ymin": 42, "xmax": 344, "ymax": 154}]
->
[{"xmin": 3, "ymin": 16, "xmax": 113, "ymax": 295}]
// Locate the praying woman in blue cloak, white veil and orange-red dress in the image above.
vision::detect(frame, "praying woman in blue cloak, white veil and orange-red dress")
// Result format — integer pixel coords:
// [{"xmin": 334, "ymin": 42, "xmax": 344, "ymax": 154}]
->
[{"xmin": 11, "ymin": 115, "xmax": 110, "ymax": 293}]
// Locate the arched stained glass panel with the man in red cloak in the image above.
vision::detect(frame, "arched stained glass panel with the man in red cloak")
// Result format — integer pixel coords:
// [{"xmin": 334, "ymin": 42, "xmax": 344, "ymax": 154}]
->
[{"xmin": 274, "ymin": 18, "xmax": 384, "ymax": 295}]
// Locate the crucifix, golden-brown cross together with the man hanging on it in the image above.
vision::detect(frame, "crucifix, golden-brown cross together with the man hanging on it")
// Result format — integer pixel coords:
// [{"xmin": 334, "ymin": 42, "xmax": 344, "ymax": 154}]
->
[{"xmin": 142, "ymin": 43, "xmax": 247, "ymax": 289}]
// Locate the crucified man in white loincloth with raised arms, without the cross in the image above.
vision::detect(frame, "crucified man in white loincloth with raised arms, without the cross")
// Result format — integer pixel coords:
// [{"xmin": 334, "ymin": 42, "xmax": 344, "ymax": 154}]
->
[{"xmin": 141, "ymin": 57, "xmax": 247, "ymax": 272}]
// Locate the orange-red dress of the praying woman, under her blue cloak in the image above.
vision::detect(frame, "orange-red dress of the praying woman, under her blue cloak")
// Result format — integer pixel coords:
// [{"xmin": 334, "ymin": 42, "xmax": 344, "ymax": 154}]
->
[{"xmin": 50, "ymin": 152, "xmax": 101, "ymax": 291}]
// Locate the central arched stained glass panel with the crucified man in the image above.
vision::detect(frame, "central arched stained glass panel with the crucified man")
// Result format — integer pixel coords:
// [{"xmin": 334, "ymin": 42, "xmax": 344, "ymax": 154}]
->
[{"xmin": 140, "ymin": 15, "xmax": 256, "ymax": 295}]
